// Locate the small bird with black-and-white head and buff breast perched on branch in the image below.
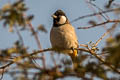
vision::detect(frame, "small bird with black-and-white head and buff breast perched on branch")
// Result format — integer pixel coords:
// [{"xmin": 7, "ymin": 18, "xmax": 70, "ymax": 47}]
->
[{"xmin": 50, "ymin": 10, "xmax": 78, "ymax": 58}]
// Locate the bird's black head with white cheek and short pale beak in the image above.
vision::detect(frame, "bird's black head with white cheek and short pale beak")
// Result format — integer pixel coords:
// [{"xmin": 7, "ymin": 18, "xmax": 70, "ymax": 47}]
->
[{"xmin": 52, "ymin": 10, "xmax": 69, "ymax": 27}]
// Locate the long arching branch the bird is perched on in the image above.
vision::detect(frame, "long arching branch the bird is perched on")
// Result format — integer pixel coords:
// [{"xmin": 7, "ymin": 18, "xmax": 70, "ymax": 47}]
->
[{"xmin": 0, "ymin": 46, "xmax": 120, "ymax": 74}]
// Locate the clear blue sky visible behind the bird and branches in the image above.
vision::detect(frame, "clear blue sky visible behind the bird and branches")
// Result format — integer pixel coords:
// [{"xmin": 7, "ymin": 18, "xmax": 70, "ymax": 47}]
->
[{"xmin": 0, "ymin": 0, "xmax": 120, "ymax": 80}]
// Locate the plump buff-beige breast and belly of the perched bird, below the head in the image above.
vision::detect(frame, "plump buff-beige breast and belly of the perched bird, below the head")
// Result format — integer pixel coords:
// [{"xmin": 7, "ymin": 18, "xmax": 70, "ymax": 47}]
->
[{"xmin": 50, "ymin": 24, "xmax": 78, "ymax": 49}]
